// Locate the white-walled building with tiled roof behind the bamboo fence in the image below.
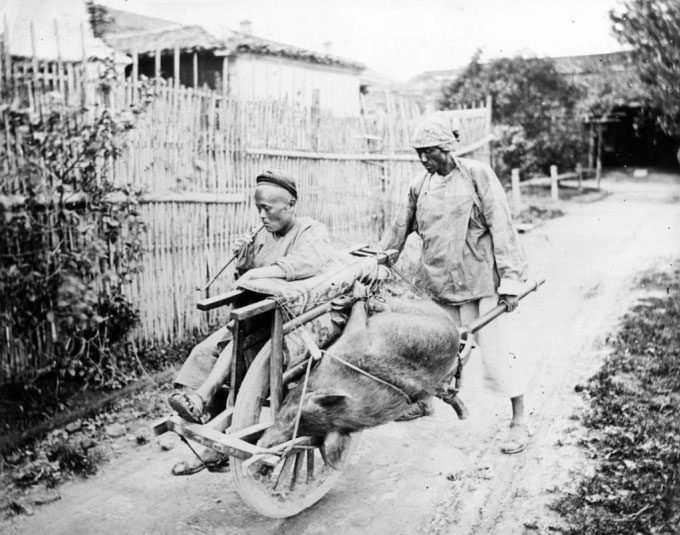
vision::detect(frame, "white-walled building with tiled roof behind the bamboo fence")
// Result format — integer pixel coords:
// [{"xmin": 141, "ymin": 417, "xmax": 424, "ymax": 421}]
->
[{"xmin": 99, "ymin": 8, "xmax": 366, "ymax": 116}]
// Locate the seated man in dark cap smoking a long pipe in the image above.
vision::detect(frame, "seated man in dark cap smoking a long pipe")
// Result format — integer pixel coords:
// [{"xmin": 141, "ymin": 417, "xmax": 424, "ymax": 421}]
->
[{"xmin": 168, "ymin": 171, "xmax": 336, "ymax": 475}]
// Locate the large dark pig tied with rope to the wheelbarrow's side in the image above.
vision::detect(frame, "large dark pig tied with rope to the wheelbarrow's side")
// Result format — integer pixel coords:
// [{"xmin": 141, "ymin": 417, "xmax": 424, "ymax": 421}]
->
[{"xmin": 258, "ymin": 288, "xmax": 460, "ymax": 467}]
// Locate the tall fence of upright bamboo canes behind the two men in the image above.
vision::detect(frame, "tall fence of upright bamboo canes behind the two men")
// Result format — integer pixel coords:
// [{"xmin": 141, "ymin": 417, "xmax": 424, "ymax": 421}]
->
[{"xmin": 0, "ymin": 43, "xmax": 491, "ymax": 384}]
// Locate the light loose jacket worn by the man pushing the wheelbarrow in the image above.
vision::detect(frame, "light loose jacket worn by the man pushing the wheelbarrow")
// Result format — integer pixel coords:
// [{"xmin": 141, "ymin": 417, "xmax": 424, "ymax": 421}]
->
[{"xmin": 381, "ymin": 158, "xmax": 527, "ymax": 304}]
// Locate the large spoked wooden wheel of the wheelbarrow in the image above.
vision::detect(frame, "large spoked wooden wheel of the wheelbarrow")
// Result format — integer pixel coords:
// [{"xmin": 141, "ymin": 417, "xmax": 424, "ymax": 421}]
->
[{"xmin": 230, "ymin": 343, "xmax": 358, "ymax": 518}]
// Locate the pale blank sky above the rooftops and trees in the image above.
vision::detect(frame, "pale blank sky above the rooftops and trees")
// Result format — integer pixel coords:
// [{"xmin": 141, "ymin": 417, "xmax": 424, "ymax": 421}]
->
[{"xmin": 98, "ymin": 0, "xmax": 622, "ymax": 81}]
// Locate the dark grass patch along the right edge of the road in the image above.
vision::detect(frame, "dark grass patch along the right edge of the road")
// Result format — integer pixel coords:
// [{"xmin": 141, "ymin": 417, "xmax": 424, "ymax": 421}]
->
[{"xmin": 555, "ymin": 270, "xmax": 680, "ymax": 535}]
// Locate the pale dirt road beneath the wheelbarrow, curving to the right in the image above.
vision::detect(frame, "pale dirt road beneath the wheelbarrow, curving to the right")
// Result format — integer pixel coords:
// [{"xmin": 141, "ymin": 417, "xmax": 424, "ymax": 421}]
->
[{"xmin": 5, "ymin": 175, "xmax": 680, "ymax": 535}]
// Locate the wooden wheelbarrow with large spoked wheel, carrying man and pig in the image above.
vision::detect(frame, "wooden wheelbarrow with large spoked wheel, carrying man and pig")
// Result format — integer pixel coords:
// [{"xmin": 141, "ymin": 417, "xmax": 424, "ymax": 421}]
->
[{"xmin": 154, "ymin": 246, "xmax": 537, "ymax": 518}]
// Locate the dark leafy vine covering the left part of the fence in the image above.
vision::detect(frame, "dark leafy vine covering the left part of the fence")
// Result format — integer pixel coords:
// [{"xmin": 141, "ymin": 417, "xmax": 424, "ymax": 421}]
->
[{"xmin": 0, "ymin": 61, "xmax": 159, "ymax": 388}]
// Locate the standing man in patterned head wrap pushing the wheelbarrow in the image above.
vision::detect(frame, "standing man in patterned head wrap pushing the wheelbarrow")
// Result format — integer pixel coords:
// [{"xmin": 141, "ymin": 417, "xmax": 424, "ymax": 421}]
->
[{"xmin": 381, "ymin": 112, "xmax": 531, "ymax": 453}]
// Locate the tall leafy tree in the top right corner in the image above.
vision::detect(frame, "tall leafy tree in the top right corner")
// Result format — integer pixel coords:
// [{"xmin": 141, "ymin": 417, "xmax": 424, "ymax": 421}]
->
[{"xmin": 610, "ymin": 0, "xmax": 680, "ymax": 136}]
